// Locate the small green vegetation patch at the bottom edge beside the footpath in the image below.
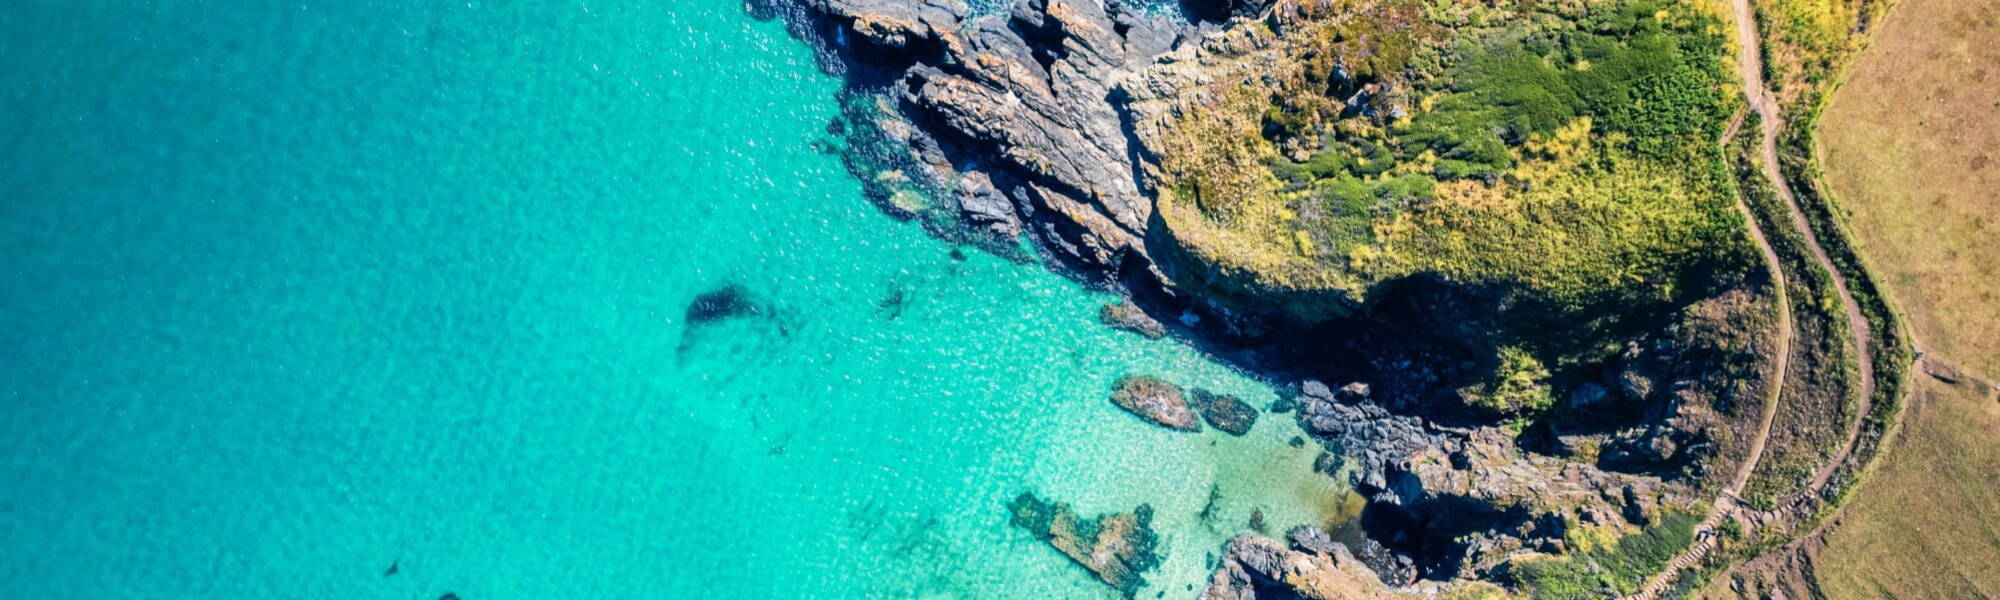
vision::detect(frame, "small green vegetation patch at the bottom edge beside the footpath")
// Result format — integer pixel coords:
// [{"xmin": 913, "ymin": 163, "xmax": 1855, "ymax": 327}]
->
[{"xmin": 1512, "ymin": 510, "xmax": 1702, "ymax": 600}]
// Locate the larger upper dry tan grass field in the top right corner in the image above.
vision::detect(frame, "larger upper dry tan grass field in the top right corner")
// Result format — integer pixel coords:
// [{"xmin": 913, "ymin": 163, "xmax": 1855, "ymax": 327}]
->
[{"xmin": 1820, "ymin": 0, "xmax": 2000, "ymax": 380}]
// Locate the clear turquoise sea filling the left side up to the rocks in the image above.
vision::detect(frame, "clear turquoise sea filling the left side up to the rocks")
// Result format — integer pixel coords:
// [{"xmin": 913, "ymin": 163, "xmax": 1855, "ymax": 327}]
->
[{"xmin": 0, "ymin": 0, "xmax": 1344, "ymax": 600}]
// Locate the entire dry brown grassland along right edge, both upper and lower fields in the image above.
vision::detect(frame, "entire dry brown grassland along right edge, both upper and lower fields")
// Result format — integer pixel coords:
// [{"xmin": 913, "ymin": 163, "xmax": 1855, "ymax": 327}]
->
[{"xmin": 1812, "ymin": 0, "xmax": 2000, "ymax": 598}]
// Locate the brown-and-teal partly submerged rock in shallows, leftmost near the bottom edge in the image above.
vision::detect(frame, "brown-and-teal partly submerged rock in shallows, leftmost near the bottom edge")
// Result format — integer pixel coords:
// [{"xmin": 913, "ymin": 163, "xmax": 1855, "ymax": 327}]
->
[{"xmin": 1008, "ymin": 492, "xmax": 1160, "ymax": 598}]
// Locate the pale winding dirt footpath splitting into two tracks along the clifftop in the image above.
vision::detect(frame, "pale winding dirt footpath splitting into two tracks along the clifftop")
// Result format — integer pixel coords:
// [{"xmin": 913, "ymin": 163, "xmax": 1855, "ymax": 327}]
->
[{"xmin": 1626, "ymin": 0, "xmax": 1874, "ymax": 600}]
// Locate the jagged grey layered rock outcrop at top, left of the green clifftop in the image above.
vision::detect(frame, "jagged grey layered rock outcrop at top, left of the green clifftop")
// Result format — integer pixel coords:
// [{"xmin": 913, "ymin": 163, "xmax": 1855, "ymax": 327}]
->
[{"xmin": 752, "ymin": 0, "xmax": 1184, "ymax": 280}]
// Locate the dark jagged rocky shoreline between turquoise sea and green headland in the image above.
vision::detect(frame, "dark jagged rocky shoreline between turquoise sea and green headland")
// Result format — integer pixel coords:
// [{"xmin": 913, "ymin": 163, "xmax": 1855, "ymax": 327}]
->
[{"xmin": 748, "ymin": 0, "xmax": 1752, "ymax": 598}]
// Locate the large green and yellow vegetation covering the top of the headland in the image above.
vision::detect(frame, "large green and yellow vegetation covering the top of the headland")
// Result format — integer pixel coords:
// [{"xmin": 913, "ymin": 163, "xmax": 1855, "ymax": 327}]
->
[{"xmin": 1160, "ymin": 0, "xmax": 1742, "ymax": 308}]
